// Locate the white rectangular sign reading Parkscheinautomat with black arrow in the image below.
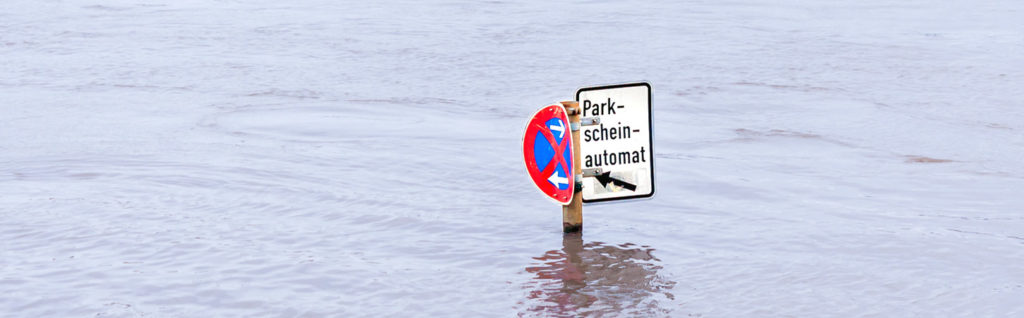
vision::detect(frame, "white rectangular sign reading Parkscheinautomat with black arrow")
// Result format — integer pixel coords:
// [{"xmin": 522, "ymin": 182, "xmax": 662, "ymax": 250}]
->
[{"xmin": 577, "ymin": 83, "xmax": 654, "ymax": 202}]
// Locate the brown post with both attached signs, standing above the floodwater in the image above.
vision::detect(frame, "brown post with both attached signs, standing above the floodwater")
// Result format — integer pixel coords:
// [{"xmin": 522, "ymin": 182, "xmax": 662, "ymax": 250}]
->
[{"xmin": 522, "ymin": 83, "xmax": 654, "ymax": 233}]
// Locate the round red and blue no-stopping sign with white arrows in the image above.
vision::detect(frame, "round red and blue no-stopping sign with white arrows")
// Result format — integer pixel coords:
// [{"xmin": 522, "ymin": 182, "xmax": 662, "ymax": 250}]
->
[{"xmin": 522, "ymin": 104, "xmax": 575, "ymax": 205}]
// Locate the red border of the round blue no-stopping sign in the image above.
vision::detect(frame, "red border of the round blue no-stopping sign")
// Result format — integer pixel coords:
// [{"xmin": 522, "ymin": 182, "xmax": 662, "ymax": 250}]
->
[{"xmin": 522, "ymin": 104, "xmax": 577, "ymax": 206}]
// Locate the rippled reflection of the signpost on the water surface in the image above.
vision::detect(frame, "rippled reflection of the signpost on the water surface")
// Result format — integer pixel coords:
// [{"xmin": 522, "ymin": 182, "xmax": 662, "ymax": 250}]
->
[{"xmin": 522, "ymin": 233, "xmax": 676, "ymax": 317}]
